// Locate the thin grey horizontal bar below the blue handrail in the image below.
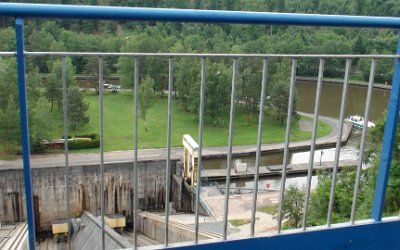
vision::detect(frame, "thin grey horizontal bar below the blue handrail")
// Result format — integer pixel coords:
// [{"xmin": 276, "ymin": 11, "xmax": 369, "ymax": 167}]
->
[{"xmin": 16, "ymin": 51, "xmax": 400, "ymax": 59}]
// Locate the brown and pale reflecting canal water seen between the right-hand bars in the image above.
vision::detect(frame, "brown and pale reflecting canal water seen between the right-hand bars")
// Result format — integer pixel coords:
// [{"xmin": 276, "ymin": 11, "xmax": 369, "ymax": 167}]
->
[{"xmin": 203, "ymin": 81, "xmax": 384, "ymax": 190}]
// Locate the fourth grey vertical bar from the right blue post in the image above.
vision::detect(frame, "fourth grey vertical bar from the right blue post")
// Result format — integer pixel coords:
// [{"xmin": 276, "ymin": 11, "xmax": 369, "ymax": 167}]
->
[{"xmin": 277, "ymin": 58, "xmax": 297, "ymax": 234}]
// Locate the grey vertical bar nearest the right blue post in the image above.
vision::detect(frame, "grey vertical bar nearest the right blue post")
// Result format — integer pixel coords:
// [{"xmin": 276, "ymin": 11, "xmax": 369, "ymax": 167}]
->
[{"xmin": 350, "ymin": 59, "xmax": 376, "ymax": 224}]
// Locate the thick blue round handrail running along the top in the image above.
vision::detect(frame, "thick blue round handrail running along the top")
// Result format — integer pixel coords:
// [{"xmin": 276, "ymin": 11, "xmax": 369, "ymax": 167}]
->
[{"xmin": 0, "ymin": 3, "xmax": 400, "ymax": 28}]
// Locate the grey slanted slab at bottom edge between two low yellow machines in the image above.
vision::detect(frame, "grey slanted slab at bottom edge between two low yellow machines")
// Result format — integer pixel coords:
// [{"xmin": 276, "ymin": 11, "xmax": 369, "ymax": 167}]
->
[{"xmin": 72, "ymin": 212, "xmax": 133, "ymax": 250}]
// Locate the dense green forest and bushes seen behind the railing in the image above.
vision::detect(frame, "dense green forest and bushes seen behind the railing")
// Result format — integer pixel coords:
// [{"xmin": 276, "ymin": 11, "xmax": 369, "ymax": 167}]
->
[{"xmin": 0, "ymin": 0, "xmax": 400, "ymax": 229}]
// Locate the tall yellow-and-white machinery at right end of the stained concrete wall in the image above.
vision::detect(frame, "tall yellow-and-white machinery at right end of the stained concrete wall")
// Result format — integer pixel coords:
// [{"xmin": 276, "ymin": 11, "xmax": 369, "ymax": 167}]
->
[{"xmin": 182, "ymin": 135, "xmax": 199, "ymax": 186}]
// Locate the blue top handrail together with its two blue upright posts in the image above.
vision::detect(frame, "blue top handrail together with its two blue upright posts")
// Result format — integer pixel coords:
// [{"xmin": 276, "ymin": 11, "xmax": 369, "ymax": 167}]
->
[{"xmin": 0, "ymin": 3, "xmax": 400, "ymax": 249}]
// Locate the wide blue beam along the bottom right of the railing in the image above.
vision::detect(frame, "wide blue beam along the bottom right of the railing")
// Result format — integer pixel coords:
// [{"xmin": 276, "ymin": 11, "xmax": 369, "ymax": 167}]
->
[{"xmin": 169, "ymin": 220, "xmax": 400, "ymax": 250}]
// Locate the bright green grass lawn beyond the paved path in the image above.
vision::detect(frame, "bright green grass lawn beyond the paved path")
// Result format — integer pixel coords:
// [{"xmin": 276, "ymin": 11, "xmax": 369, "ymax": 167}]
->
[{"xmin": 50, "ymin": 94, "xmax": 331, "ymax": 152}]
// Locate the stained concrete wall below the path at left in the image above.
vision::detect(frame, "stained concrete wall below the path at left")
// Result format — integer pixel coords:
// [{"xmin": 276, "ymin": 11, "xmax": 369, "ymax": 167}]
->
[{"xmin": 0, "ymin": 160, "xmax": 176, "ymax": 230}]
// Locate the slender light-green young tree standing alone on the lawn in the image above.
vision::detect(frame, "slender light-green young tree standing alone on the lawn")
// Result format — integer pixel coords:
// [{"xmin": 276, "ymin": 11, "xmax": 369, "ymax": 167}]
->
[{"xmin": 138, "ymin": 77, "xmax": 154, "ymax": 132}]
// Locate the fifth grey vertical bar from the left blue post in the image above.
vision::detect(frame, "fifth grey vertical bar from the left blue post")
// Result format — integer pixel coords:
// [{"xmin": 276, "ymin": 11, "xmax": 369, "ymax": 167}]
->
[{"xmin": 194, "ymin": 57, "xmax": 206, "ymax": 244}]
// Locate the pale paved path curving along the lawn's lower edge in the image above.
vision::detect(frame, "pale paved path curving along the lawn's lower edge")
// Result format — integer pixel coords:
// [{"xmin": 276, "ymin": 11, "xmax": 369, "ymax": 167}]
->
[{"xmin": 0, "ymin": 113, "xmax": 352, "ymax": 170}]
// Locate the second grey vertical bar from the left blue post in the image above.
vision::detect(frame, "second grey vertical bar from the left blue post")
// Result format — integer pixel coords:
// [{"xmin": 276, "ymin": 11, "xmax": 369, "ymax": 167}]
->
[{"xmin": 99, "ymin": 57, "xmax": 106, "ymax": 250}]
